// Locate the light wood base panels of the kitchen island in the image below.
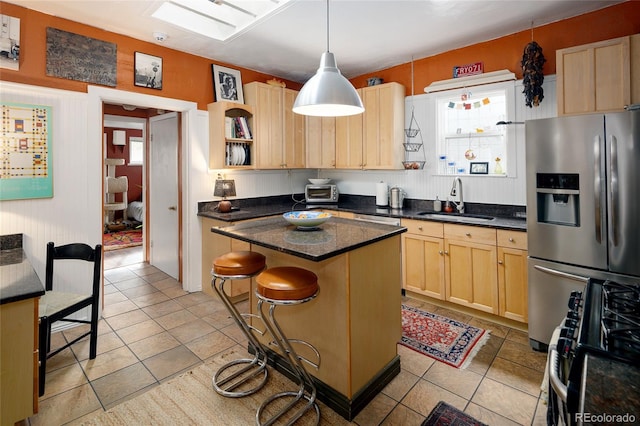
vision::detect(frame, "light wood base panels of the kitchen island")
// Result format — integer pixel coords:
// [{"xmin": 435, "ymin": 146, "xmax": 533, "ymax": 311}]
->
[{"xmin": 251, "ymin": 235, "xmax": 402, "ymax": 399}]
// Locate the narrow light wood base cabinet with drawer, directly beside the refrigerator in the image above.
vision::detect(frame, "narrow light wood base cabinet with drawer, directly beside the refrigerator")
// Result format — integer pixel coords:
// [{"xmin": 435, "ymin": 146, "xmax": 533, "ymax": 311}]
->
[{"xmin": 497, "ymin": 229, "xmax": 528, "ymax": 323}]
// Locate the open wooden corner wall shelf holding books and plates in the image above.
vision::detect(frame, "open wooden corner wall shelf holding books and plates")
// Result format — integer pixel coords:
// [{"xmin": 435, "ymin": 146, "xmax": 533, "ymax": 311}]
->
[{"xmin": 207, "ymin": 101, "xmax": 255, "ymax": 169}]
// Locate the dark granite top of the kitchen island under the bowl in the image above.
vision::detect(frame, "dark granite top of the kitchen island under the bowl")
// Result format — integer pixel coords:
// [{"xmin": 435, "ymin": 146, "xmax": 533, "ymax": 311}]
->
[{"xmin": 211, "ymin": 217, "xmax": 407, "ymax": 262}]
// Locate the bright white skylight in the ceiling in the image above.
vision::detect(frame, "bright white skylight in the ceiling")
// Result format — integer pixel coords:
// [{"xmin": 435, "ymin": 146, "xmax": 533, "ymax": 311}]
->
[{"xmin": 151, "ymin": 0, "xmax": 290, "ymax": 41}]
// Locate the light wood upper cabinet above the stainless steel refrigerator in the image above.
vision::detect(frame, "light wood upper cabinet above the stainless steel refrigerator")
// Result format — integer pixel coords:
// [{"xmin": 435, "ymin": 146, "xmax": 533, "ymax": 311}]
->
[{"xmin": 556, "ymin": 35, "xmax": 640, "ymax": 115}]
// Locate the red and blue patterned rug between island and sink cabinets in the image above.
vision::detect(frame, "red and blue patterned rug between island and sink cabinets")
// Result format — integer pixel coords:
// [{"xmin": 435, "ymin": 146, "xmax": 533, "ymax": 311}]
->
[{"xmin": 400, "ymin": 305, "xmax": 489, "ymax": 368}]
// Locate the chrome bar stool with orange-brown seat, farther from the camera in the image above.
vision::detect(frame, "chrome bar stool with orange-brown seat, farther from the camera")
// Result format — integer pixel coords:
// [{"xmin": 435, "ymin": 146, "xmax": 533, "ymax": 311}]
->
[{"xmin": 211, "ymin": 251, "xmax": 268, "ymax": 398}]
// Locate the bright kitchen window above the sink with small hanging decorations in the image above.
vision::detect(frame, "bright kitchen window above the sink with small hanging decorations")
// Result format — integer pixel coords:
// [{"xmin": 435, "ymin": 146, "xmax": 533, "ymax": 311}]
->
[{"xmin": 436, "ymin": 83, "xmax": 515, "ymax": 176}]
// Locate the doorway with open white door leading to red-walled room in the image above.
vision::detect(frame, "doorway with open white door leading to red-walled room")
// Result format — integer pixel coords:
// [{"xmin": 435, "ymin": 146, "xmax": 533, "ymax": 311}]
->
[{"xmin": 103, "ymin": 103, "xmax": 180, "ymax": 280}]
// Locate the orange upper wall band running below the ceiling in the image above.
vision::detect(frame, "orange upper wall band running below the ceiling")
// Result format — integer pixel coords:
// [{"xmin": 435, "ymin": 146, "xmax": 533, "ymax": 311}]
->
[{"xmin": 0, "ymin": 1, "xmax": 640, "ymax": 101}]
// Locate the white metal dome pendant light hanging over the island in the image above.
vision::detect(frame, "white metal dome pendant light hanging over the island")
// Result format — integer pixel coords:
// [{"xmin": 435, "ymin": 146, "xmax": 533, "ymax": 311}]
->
[{"xmin": 293, "ymin": 0, "xmax": 364, "ymax": 117}]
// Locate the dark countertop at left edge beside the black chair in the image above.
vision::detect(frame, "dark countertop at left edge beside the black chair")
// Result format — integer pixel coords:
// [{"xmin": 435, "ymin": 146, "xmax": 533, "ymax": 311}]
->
[{"xmin": 0, "ymin": 234, "xmax": 44, "ymax": 305}]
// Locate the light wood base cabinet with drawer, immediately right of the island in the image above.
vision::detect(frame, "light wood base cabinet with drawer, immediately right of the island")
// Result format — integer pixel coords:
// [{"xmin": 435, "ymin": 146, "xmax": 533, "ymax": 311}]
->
[{"xmin": 402, "ymin": 219, "xmax": 445, "ymax": 299}]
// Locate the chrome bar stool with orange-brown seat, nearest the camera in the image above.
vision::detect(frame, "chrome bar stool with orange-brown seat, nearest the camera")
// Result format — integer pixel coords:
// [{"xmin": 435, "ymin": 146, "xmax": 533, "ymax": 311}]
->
[{"xmin": 256, "ymin": 266, "xmax": 320, "ymax": 425}]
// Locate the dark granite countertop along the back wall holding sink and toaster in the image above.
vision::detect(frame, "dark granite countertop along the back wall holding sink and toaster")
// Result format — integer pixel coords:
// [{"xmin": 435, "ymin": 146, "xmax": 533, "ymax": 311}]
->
[{"xmin": 198, "ymin": 194, "xmax": 527, "ymax": 231}]
